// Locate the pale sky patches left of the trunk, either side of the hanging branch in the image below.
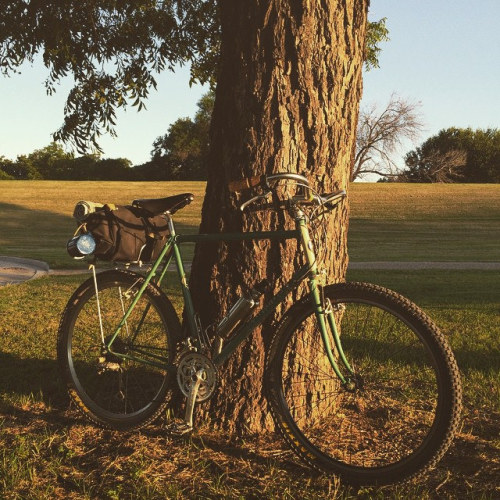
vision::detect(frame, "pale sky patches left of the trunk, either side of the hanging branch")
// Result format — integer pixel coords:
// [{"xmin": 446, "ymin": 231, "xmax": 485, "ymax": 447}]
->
[{"xmin": 0, "ymin": 59, "xmax": 207, "ymax": 164}]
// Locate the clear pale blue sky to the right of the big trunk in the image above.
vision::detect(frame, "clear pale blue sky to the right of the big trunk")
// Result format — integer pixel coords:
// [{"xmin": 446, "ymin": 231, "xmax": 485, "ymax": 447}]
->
[{"xmin": 363, "ymin": 0, "xmax": 500, "ymax": 140}]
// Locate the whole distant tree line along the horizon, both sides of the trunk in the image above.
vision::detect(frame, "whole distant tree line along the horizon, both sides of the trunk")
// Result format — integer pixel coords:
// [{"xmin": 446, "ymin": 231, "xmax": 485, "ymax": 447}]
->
[{"xmin": 0, "ymin": 92, "xmax": 500, "ymax": 183}]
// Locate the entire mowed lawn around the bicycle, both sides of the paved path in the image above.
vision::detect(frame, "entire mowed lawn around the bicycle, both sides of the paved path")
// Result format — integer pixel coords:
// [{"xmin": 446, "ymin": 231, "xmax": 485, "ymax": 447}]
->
[{"xmin": 0, "ymin": 181, "xmax": 500, "ymax": 500}]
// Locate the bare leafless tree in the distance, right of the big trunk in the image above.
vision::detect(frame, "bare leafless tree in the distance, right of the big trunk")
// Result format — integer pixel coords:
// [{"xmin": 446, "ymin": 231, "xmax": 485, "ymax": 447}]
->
[{"xmin": 351, "ymin": 94, "xmax": 423, "ymax": 181}]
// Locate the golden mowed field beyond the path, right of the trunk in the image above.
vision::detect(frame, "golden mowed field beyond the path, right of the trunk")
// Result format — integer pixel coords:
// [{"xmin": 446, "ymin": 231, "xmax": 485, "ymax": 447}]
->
[{"xmin": 349, "ymin": 183, "xmax": 500, "ymax": 262}]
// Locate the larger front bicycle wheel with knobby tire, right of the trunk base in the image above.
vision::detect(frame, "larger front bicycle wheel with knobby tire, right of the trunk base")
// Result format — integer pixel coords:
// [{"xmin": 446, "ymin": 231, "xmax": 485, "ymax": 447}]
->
[{"xmin": 266, "ymin": 283, "xmax": 461, "ymax": 485}]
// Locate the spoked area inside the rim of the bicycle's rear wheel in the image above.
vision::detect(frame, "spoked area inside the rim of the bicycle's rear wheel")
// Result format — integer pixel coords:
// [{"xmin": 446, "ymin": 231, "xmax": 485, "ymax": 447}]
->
[{"xmin": 63, "ymin": 274, "xmax": 170, "ymax": 426}]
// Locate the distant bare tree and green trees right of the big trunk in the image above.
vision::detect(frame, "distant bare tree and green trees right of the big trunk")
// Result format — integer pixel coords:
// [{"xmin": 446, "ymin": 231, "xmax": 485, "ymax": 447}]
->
[{"xmin": 351, "ymin": 94, "xmax": 500, "ymax": 183}]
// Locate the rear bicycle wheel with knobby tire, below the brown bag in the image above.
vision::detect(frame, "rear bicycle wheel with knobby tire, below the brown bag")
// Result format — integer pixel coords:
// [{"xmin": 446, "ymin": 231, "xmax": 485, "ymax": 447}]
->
[{"xmin": 57, "ymin": 271, "xmax": 180, "ymax": 430}]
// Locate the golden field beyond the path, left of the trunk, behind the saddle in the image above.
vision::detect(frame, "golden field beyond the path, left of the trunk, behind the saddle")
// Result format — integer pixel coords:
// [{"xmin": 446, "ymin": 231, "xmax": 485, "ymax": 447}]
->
[{"xmin": 0, "ymin": 181, "xmax": 205, "ymax": 269}]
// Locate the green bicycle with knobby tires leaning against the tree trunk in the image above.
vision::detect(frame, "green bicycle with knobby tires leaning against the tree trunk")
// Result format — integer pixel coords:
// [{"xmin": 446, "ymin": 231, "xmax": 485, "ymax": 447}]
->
[{"xmin": 57, "ymin": 173, "xmax": 461, "ymax": 485}]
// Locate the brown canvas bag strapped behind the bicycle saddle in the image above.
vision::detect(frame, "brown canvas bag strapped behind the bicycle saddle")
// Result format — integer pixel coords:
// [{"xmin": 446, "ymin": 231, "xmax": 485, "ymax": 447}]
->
[{"xmin": 82, "ymin": 205, "xmax": 169, "ymax": 262}]
